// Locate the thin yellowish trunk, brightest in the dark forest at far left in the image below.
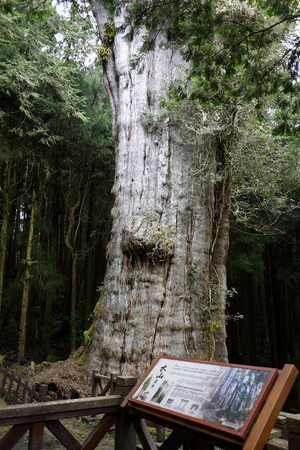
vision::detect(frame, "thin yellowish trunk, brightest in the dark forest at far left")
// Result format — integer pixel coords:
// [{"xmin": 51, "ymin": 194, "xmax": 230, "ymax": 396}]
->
[{"xmin": 18, "ymin": 191, "xmax": 36, "ymax": 360}]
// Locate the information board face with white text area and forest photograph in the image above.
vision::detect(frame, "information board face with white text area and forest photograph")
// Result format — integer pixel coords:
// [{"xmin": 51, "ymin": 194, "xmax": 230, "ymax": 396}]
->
[{"xmin": 130, "ymin": 357, "xmax": 276, "ymax": 436}]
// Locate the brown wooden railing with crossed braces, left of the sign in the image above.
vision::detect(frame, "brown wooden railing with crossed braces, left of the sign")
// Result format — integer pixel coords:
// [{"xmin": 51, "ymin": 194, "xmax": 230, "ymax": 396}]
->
[{"xmin": 0, "ymin": 377, "xmax": 136, "ymax": 450}]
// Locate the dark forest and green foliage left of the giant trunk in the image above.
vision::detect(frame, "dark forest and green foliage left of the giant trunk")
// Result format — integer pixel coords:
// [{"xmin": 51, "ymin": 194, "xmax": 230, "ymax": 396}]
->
[{"xmin": 0, "ymin": 0, "xmax": 113, "ymax": 360}]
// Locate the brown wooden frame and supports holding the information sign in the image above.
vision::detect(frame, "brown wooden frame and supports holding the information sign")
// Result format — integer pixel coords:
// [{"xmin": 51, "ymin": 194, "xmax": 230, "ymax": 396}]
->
[{"xmin": 120, "ymin": 354, "xmax": 298, "ymax": 450}]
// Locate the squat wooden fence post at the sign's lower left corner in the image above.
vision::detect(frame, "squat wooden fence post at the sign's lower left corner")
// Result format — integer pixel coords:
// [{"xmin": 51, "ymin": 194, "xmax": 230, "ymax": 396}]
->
[{"xmin": 115, "ymin": 376, "xmax": 137, "ymax": 450}]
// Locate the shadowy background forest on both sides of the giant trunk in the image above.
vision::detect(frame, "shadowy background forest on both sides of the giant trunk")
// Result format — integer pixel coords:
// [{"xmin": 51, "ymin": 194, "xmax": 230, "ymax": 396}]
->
[{"xmin": 0, "ymin": 1, "xmax": 300, "ymax": 410}]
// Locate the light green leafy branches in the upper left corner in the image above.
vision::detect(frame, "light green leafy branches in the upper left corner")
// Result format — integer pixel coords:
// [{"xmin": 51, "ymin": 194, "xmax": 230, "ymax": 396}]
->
[{"xmin": 0, "ymin": 0, "xmax": 86, "ymax": 145}]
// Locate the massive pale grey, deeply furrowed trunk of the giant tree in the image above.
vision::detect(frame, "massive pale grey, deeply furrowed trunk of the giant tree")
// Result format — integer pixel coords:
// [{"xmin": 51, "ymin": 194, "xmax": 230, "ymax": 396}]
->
[{"xmin": 86, "ymin": 0, "xmax": 229, "ymax": 374}]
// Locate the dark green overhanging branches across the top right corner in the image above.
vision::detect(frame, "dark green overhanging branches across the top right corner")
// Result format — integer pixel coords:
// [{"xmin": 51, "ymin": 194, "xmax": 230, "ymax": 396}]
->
[{"xmin": 119, "ymin": 0, "xmax": 300, "ymax": 133}]
